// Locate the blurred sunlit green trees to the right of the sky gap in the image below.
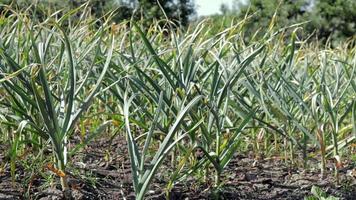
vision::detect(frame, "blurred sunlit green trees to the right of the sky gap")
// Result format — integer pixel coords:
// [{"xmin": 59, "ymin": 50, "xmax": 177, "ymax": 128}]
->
[{"xmin": 224, "ymin": 0, "xmax": 356, "ymax": 42}]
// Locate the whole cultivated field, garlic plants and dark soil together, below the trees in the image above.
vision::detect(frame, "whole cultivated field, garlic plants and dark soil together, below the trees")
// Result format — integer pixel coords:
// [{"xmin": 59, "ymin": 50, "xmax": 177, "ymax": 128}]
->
[{"xmin": 0, "ymin": 7, "xmax": 356, "ymax": 199}]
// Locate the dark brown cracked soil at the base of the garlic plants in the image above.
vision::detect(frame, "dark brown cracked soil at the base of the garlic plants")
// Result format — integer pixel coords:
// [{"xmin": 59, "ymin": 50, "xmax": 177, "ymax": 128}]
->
[{"xmin": 0, "ymin": 136, "xmax": 356, "ymax": 200}]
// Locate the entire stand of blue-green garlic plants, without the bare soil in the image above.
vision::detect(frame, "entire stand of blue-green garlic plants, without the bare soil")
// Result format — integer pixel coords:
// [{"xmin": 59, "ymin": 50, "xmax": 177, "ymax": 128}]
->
[{"xmin": 0, "ymin": 5, "xmax": 356, "ymax": 199}]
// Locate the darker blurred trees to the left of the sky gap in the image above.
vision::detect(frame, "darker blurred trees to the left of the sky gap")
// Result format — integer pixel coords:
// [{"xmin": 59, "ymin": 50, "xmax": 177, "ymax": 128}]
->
[{"xmin": 0, "ymin": 0, "xmax": 195, "ymax": 26}]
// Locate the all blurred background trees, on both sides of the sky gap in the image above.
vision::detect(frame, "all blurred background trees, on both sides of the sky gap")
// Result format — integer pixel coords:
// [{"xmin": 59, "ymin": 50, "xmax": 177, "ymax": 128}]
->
[{"xmin": 0, "ymin": 0, "xmax": 356, "ymax": 43}]
